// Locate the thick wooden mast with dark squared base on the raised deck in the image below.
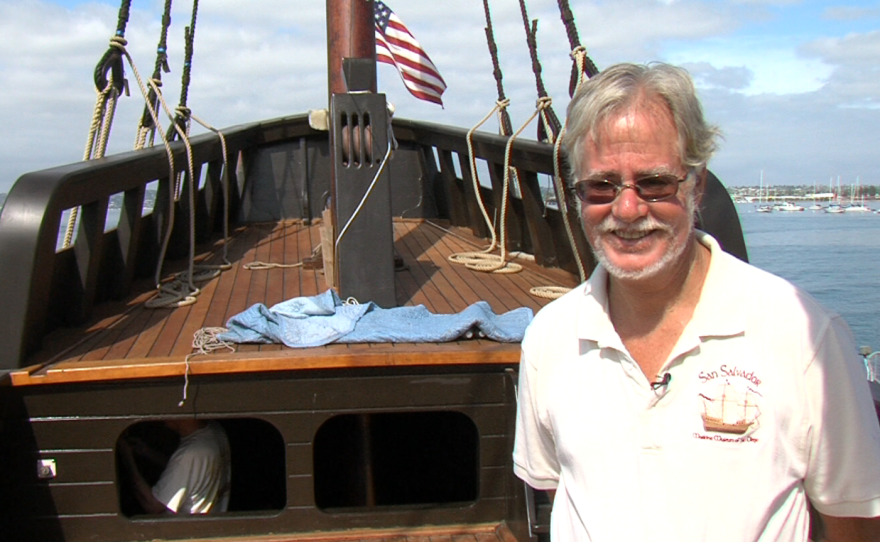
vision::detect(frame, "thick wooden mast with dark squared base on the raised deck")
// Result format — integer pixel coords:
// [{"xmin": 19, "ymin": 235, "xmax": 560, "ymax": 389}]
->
[{"xmin": 322, "ymin": 0, "xmax": 397, "ymax": 308}]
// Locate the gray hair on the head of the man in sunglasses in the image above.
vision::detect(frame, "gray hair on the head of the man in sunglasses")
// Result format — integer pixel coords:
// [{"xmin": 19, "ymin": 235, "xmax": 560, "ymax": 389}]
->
[{"xmin": 562, "ymin": 62, "xmax": 721, "ymax": 179}]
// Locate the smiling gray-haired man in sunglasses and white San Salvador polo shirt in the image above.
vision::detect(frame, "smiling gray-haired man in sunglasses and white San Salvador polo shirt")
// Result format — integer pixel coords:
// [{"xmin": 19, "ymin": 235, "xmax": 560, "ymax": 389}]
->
[{"xmin": 514, "ymin": 64, "xmax": 880, "ymax": 542}]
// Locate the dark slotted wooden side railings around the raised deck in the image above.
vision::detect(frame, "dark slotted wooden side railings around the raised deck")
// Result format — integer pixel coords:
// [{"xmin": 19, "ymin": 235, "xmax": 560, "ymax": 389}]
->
[{"xmin": 0, "ymin": 115, "xmax": 589, "ymax": 369}]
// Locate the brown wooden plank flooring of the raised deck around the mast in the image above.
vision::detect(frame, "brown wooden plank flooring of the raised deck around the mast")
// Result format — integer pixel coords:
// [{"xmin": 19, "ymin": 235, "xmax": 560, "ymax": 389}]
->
[{"xmin": 13, "ymin": 219, "xmax": 578, "ymax": 385}]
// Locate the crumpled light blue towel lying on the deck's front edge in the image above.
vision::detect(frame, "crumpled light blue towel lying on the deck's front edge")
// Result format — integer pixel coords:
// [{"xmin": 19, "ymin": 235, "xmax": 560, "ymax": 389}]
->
[{"xmin": 218, "ymin": 290, "xmax": 532, "ymax": 348}]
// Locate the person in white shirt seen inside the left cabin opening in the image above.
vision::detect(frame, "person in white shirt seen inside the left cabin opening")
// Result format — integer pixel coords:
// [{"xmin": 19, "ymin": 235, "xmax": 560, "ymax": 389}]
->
[{"xmin": 119, "ymin": 418, "xmax": 231, "ymax": 514}]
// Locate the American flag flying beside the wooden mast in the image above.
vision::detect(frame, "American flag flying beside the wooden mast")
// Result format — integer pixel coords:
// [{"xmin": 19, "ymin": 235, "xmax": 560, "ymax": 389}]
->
[{"xmin": 373, "ymin": 0, "xmax": 446, "ymax": 105}]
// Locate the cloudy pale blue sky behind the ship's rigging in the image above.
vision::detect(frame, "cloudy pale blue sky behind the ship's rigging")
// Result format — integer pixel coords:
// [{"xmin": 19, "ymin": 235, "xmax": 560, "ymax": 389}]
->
[{"xmin": 0, "ymin": 0, "xmax": 880, "ymax": 192}]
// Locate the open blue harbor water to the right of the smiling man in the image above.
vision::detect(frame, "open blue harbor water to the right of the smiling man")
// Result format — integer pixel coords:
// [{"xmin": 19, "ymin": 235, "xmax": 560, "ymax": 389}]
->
[{"xmin": 737, "ymin": 202, "xmax": 880, "ymax": 350}]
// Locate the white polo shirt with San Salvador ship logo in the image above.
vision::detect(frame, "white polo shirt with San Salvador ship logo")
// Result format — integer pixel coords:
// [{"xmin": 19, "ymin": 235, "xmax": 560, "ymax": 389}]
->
[{"xmin": 513, "ymin": 232, "xmax": 880, "ymax": 542}]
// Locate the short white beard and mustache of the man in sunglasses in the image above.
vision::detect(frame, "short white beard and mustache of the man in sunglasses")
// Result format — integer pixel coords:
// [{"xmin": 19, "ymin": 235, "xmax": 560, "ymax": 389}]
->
[{"xmin": 587, "ymin": 194, "xmax": 696, "ymax": 280}]
